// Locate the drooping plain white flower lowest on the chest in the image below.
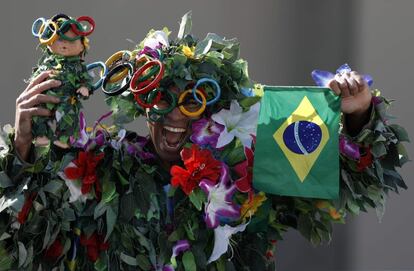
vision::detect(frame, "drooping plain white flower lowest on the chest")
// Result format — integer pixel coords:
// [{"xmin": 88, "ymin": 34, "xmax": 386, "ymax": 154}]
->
[{"xmin": 207, "ymin": 223, "xmax": 248, "ymax": 263}]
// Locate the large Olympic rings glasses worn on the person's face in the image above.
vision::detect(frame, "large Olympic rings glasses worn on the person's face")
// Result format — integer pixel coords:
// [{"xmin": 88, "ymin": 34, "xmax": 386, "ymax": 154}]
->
[{"xmin": 102, "ymin": 50, "xmax": 221, "ymax": 122}]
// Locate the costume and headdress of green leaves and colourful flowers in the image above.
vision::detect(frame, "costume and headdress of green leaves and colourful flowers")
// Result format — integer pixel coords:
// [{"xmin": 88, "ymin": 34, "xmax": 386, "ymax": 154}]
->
[{"xmin": 0, "ymin": 11, "xmax": 408, "ymax": 271}]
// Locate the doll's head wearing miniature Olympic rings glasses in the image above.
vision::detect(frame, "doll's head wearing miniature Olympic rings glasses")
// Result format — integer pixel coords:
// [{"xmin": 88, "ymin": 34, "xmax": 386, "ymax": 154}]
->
[{"xmin": 32, "ymin": 14, "xmax": 94, "ymax": 57}]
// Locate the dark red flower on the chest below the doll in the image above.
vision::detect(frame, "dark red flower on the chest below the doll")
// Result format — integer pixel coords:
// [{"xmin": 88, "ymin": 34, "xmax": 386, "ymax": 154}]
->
[{"xmin": 65, "ymin": 151, "xmax": 104, "ymax": 198}]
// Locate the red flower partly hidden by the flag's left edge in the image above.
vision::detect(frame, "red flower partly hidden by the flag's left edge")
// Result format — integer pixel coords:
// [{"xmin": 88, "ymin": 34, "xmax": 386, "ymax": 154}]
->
[{"xmin": 234, "ymin": 148, "xmax": 253, "ymax": 193}]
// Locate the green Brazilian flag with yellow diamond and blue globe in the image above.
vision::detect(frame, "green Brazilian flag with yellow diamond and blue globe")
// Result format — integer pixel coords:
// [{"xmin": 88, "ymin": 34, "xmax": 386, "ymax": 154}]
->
[{"xmin": 253, "ymin": 86, "xmax": 341, "ymax": 199}]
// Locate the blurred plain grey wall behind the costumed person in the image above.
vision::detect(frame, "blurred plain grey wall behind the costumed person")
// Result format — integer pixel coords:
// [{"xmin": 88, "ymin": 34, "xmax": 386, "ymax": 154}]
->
[{"xmin": 0, "ymin": 0, "xmax": 414, "ymax": 271}]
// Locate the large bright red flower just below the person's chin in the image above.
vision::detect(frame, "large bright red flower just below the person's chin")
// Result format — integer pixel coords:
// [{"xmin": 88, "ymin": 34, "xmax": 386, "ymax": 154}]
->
[{"xmin": 171, "ymin": 144, "xmax": 221, "ymax": 195}]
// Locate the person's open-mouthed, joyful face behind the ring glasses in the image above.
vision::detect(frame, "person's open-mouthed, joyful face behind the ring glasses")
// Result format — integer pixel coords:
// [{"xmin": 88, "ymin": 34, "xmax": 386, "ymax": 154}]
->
[{"xmin": 147, "ymin": 89, "xmax": 203, "ymax": 163}]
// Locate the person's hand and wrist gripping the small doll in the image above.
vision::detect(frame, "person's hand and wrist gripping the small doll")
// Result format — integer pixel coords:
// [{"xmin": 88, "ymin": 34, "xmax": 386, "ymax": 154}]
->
[{"xmin": 14, "ymin": 71, "xmax": 61, "ymax": 163}]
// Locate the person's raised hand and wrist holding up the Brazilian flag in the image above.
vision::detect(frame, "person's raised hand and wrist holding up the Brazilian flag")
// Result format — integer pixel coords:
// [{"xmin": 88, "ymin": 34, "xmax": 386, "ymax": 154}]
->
[{"xmin": 328, "ymin": 71, "xmax": 372, "ymax": 135}]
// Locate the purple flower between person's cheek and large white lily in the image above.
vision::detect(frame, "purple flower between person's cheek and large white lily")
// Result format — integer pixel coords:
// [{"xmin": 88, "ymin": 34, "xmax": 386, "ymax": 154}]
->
[{"xmin": 190, "ymin": 118, "xmax": 224, "ymax": 148}]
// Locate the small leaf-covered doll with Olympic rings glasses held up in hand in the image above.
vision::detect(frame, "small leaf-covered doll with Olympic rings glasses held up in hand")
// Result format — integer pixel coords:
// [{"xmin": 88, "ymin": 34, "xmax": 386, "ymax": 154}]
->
[{"xmin": 31, "ymin": 14, "xmax": 94, "ymax": 148}]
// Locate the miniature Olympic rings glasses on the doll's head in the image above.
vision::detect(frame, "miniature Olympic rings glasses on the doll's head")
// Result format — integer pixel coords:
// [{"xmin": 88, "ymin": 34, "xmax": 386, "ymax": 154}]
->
[{"xmin": 32, "ymin": 16, "xmax": 95, "ymax": 45}]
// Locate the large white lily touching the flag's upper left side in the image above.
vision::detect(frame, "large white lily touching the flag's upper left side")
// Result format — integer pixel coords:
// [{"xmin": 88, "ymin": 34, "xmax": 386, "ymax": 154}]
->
[{"xmin": 211, "ymin": 100, "xmax": 260, "ymax": 148}]
